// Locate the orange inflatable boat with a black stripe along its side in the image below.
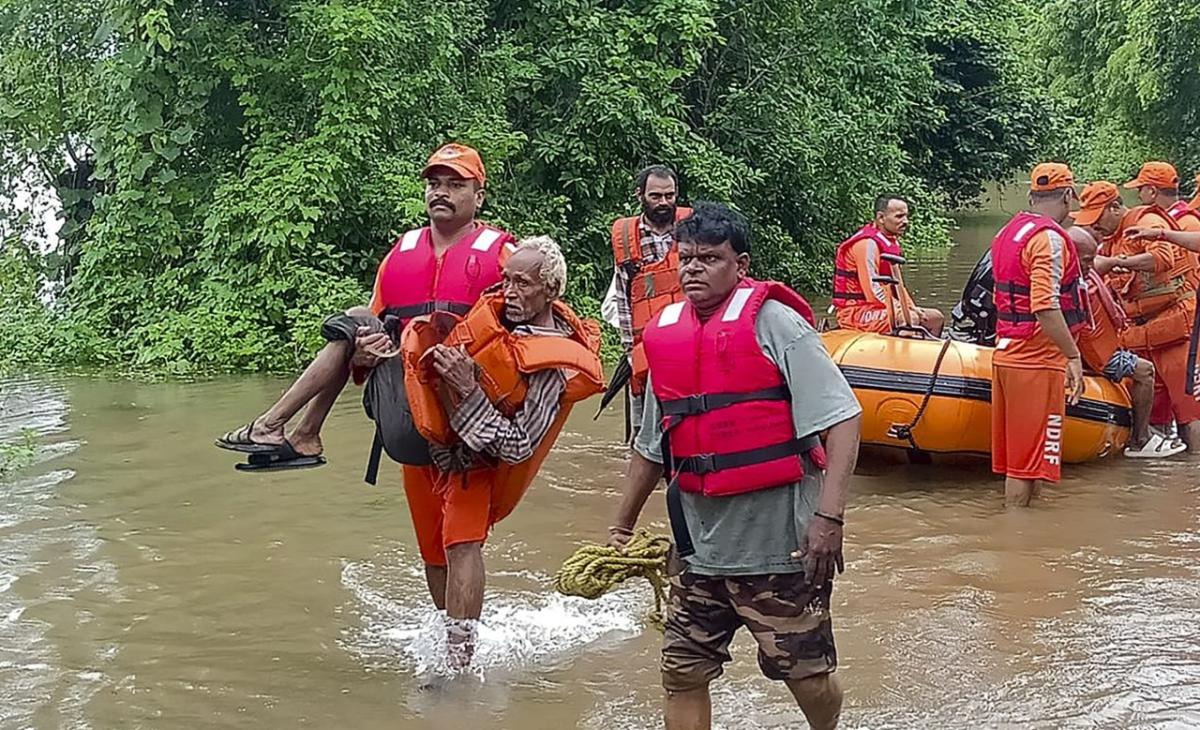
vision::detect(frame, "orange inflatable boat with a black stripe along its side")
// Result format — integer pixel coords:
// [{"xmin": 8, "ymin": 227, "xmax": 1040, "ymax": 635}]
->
[{"xmin": 821, "ymin": 329, "xmax": 1132, "ymax": 463}]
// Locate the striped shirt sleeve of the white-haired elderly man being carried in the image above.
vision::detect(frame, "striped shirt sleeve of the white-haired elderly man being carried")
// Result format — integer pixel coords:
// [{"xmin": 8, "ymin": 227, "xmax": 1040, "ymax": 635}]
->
[{"xmin": 450, "ymin": 369, "xmax": 566, "ymax": 463}]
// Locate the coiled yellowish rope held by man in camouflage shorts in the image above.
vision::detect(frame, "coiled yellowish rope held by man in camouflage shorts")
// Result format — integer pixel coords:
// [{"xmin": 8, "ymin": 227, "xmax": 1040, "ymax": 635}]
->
[{"xmin": 554, "ymin": 529, "xmax": 671, "ymax": 629}]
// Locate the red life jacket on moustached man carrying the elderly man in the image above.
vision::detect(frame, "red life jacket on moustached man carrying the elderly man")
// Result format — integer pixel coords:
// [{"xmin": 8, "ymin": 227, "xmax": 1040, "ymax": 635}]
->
[{"xmin": 372, "ymin": 223, "xmax": 514, "ymax": 331}]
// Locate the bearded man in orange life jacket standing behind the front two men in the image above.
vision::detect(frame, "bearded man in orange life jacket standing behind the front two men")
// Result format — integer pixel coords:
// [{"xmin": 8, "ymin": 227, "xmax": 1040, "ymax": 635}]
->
[{"xmin": 605, "ymin": 164, "xmax": 691, "ymax": 433}]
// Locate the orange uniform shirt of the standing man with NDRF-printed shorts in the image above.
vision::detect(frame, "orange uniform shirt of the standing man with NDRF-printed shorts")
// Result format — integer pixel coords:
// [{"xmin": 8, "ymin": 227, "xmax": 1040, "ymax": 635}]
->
[{"xmin": 992, "ymin": 231, "xmax": 1075, "ymax": 372}]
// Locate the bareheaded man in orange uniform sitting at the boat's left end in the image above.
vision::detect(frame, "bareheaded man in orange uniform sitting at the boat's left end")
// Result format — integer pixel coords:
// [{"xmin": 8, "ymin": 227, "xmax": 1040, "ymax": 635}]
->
[{"xmin": 833, "ymin": 195, "xmax": 946, "ymax": 336}]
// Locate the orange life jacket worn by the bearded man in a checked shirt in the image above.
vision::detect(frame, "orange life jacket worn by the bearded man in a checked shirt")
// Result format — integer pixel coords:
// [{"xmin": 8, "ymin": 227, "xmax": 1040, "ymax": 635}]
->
[{"xmin": 612, "ymin": 207, "xmax": 691, "ymax": 395}]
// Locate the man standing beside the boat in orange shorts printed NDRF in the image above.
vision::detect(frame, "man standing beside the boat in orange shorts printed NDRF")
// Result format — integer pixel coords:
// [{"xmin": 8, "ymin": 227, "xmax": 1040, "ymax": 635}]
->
[{"xmin": 991, "ymin": 162, "xmax": 1086, "ymax": 507}]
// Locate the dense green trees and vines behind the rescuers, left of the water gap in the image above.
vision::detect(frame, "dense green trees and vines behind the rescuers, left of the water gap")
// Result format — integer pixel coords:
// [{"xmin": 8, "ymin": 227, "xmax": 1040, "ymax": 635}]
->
[{"xmin": 0, "ymin": 0, "xmax": 1060, "ymax": 370}]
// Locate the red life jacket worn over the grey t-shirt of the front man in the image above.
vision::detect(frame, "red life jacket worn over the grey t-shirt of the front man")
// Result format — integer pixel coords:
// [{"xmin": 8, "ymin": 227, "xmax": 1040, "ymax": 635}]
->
[{"xmin": 642, "ymin": 279, "xmax": 824, "ymax": 497}]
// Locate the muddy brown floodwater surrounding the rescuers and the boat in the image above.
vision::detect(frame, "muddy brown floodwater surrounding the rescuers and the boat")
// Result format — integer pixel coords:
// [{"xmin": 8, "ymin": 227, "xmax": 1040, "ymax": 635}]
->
[{"xmin": 0, "ymin": 200, "xmax": 1200, "ymax": 730}]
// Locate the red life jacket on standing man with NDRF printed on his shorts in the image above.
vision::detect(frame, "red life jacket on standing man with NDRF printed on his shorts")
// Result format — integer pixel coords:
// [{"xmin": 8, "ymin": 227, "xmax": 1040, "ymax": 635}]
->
[{"xmin": 991, "ymin": 213, "xmax": 1087, "ymax": 340}]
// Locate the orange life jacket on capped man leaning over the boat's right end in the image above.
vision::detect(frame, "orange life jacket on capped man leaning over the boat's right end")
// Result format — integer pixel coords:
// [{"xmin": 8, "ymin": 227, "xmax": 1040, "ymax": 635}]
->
[{"xmin": 1109, "ymin": 205, "xmax": 1195, "ymax": 328}]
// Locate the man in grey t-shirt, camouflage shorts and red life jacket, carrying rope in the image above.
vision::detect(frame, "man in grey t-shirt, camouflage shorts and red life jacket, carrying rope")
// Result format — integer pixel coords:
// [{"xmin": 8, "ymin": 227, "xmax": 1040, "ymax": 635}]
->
[{"xmin": 608, "ymin": 203, "xmax": 862, "ymax": 730}]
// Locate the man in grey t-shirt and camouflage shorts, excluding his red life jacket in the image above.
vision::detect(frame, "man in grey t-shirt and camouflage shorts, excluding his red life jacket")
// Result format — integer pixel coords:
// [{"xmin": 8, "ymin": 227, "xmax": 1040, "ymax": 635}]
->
[{"xmin": 610, "ymin": 204, "xmax": 862, "ymax": 730}]
